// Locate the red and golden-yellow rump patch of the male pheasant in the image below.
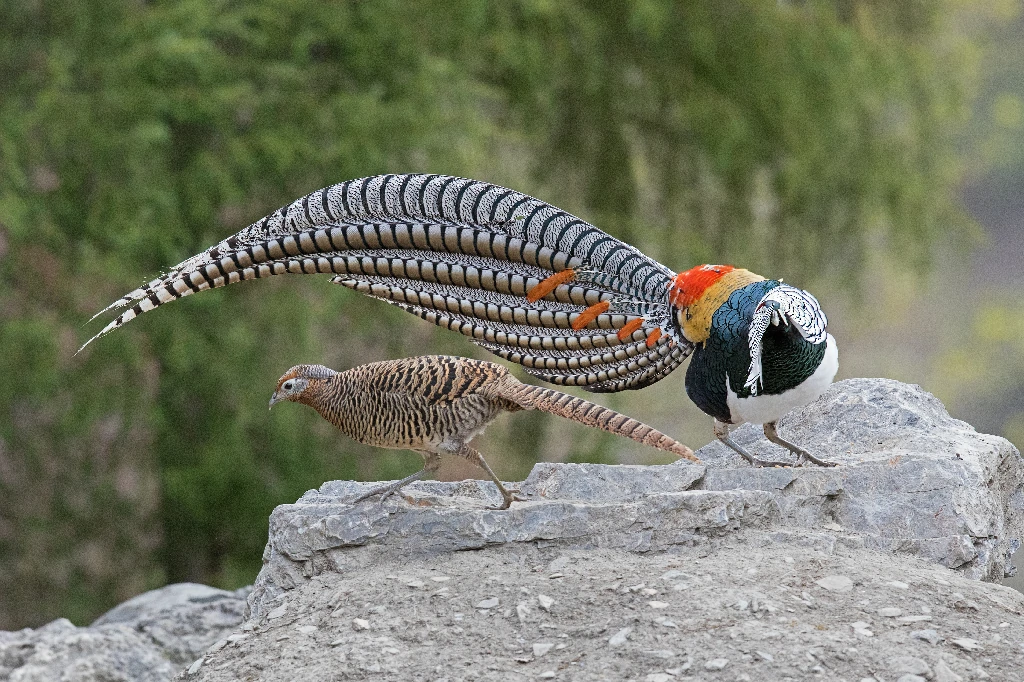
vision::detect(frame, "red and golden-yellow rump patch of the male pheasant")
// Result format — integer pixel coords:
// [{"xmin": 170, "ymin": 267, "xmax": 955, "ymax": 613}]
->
[{"xmin": 669, "ymin": 265, "xmax": 764, "ymax": 343}]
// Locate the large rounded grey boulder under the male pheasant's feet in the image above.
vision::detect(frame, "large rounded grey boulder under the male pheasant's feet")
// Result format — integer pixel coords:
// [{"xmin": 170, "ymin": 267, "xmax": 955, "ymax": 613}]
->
[{"xmin": 697, "ymin": 379, "xmax": 1024, "ymax": 581}]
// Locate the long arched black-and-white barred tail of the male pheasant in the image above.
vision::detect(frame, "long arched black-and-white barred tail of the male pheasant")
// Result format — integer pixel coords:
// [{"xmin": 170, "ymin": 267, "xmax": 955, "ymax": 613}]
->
[{"xmin": 83, "ymin": 175, "xmax": 690, "ymax": 391}]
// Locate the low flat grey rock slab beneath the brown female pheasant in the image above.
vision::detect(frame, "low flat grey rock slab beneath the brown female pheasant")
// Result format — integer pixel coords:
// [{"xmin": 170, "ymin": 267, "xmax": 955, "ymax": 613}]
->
[{"xmin": 249, "ymin": 483, "xmax": 778, "ymax": 616}]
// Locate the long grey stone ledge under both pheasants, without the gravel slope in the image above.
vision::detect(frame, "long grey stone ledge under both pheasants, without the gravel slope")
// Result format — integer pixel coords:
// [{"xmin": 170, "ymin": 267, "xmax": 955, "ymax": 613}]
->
[{"xmin": 250, "ymin": 379, "xmax": 1024, "ymax": 615}]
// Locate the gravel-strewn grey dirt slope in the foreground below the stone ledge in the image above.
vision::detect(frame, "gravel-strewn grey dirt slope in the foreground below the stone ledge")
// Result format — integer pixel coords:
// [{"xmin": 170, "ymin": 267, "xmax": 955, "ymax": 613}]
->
[{"xmin": 178, "ymin": 528, "xmax": 1024, "ymax": 682}]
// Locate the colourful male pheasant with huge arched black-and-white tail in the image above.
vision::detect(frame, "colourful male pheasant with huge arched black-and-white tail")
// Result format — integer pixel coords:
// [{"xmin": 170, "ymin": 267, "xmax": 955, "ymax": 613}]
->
[{"xmin": 83, "ymin": 175, "xmax": 837, "ymax": 464}]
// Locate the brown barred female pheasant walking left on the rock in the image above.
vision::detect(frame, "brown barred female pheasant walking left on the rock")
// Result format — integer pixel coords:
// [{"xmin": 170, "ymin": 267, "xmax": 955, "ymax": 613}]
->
[{"xmin": 270, "ymin": 355, "xmax": 699, "ymax": 509}]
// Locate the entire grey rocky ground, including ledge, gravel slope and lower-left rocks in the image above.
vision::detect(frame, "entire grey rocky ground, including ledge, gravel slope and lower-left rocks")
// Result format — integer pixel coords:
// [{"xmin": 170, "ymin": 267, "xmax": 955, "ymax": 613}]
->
[{"xmin": 0, "ymin": 379, "xmax": 1024, "ymax": 682}]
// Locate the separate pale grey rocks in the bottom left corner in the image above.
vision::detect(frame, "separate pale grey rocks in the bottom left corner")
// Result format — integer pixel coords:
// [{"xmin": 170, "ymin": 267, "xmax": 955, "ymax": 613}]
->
[{"xmin": 0, "ymin": 583, "xmax": 248, "ymax": 682}]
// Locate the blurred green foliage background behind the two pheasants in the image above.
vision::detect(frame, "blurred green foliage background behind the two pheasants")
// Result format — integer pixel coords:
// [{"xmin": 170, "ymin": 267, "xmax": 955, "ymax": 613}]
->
[{"xmin": 0, "ymin": 0, "xmax": 1024, "ymax": 630}]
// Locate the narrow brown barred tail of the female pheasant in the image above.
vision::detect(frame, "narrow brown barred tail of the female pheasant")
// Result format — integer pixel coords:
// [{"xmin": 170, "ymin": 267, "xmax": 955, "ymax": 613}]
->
[{"xmin": 503, "ymin": 376, "xmax": 700, "ymax": 462}]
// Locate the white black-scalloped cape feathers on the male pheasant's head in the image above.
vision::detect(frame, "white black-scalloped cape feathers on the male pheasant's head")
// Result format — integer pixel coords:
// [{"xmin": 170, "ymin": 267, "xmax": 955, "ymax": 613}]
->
[{"xmin": 743, "ymin": 284, "xmax": 828, "ymax": 395}]
